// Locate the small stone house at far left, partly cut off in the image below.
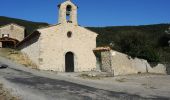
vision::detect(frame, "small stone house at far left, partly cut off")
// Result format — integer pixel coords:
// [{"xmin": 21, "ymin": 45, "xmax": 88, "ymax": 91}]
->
[{"xmin": 0, "ymin": 23, "xmax": 25, "ymax": 48}]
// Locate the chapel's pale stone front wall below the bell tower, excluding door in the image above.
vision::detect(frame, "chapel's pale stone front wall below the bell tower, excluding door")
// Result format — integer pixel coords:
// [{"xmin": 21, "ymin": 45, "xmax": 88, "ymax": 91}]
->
[{"xmin": 38, "ymin": 23, "xmax": 97, "ymax": 72}]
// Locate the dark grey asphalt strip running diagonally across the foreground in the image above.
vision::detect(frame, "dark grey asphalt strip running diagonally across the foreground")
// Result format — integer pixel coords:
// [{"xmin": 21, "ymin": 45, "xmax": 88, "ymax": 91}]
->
[{"xmin": 6, "ymin": 76, "xmax": 169, "ymax": 100}]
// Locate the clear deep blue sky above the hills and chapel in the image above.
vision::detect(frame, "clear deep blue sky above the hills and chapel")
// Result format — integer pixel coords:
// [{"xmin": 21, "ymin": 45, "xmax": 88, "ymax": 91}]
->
[{"xmin": 0, "ymin": 0, "xmax": 170, "ymax": 26}]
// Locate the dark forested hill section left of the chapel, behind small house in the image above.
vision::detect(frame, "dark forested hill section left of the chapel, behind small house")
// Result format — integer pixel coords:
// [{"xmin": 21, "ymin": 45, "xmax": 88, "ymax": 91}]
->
[{"xmin": 0, "ymin": 16, "xmax": 48, "ymax": 35}]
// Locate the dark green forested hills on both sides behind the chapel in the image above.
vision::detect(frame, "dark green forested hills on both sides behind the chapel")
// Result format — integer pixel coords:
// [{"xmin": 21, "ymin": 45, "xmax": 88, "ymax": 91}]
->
[{"xmin": 0, "ymin": 16, "xmax": 170, "ymax": 63}]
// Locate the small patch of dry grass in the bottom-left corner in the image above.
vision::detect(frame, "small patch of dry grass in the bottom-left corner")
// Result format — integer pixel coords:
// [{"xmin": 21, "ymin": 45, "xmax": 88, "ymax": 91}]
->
[{"xmin": 0, "ymin": 83, "xmax": 21, "ymax": 100}]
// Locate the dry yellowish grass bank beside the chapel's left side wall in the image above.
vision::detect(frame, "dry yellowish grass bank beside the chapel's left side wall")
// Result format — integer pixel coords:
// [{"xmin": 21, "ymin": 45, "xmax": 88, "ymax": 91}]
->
[{"xmin": 0, "ymin": 48, "xmax": 37, "ymax": 69}]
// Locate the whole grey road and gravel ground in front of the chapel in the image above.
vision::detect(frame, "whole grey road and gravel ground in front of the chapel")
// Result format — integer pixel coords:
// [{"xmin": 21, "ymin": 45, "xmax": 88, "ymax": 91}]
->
[{"xmin": 0, "ymin": 58, "xmax": 170, "ymax": 100}]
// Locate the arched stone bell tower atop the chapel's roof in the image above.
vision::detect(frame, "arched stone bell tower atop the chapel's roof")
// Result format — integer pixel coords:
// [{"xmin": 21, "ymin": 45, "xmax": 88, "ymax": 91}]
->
[{"xmin": 58, "ymin": 0, "xmax": 78, "ymax": 25}]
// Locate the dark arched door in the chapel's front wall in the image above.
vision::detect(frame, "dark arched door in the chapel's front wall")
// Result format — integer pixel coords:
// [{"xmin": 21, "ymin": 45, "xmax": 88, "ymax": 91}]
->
[{"xmin": 65, "ymin": 52, "xmax": 74, "ymax": 72}]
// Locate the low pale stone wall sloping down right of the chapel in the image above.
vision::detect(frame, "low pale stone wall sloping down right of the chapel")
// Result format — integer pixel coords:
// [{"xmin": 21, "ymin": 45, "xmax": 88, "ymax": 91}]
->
[{"xmin": 101, "ymin": 50, "xmax": 166, "ymax": 75}]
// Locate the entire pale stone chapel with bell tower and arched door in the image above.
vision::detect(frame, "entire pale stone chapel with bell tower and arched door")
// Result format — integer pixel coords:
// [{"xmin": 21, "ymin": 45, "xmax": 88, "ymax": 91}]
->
[{"xmin": 17, "ymin": 0, "xmax": 97, "ymax": 72}]
